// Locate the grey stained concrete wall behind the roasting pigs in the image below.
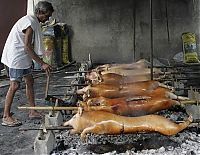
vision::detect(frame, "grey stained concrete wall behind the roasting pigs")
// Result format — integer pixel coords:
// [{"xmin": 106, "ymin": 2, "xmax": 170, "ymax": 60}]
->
[{"xmin": 34, "ymin": 0, "xmax": 199, "ymax": 63}]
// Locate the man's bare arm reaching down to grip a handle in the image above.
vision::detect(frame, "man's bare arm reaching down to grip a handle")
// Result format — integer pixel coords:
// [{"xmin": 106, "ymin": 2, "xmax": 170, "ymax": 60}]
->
[{"xmin": 23, "ymin": 26, "xmax": 52, "ymax": 73}]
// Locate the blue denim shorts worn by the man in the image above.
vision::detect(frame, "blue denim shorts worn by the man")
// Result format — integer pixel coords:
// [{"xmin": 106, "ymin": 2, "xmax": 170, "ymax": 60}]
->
[{"xmin": 9, "ymin": 68, "xmax": 32, "ymax": 82}]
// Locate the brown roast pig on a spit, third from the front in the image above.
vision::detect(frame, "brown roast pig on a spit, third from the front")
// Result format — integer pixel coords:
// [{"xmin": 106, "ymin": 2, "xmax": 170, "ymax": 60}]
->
[{"xmin": 77, "ymin": 80, "xmax": 170, "ymax": 98}]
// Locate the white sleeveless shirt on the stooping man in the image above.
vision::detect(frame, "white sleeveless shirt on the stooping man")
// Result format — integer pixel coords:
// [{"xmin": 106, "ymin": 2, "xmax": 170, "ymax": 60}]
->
[{"xmin": 1, "ymin": 15, "xmax": 43, "ymax": 69}]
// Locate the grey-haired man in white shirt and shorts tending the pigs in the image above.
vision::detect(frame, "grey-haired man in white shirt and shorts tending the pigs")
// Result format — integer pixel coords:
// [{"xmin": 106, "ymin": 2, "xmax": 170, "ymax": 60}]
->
[{"xmin": 1, "ymin": 1, "xmax": 54, "ymax": 126}]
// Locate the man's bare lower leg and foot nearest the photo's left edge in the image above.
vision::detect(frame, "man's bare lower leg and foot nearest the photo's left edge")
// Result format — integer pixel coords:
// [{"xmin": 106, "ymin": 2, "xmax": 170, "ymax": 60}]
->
[{"xmin": 3, "ymin": 81, "xmax": 20, "ymax": 122}]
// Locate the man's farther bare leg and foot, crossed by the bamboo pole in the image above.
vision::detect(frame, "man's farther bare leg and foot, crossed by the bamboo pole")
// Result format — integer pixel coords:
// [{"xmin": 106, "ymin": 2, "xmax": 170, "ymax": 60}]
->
[{"xmin": 24, "ymin": 74, "xmax": 41, "ymax": 118}]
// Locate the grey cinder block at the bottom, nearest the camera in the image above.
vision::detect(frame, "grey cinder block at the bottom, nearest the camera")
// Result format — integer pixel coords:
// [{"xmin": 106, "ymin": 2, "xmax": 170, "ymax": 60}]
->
[{"xmin": 34, "ymin": 131, "xmax": 56, "ymax": 155}]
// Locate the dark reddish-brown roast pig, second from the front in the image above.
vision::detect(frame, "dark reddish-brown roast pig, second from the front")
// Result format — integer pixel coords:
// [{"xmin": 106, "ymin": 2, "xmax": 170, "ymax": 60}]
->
[{"xmin": 86, "ymin": 97, "xmax": 179, "ymax": 116}]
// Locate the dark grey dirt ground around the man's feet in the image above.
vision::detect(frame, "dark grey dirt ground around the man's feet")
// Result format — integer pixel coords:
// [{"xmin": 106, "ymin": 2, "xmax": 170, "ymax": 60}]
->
[{"xmin": 0, "ymin": 69, "xmax": 72, "ymax": 155}]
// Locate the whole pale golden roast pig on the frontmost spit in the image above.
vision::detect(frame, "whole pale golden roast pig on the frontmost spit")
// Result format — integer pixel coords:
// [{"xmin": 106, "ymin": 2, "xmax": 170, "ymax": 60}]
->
[{"xmin": 63, "ymin": 110, "xmax": 192, "ymax": 140}]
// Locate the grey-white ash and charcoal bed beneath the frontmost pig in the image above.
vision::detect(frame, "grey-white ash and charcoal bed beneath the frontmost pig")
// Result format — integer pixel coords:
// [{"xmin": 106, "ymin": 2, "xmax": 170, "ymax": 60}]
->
[{"xmin": 51, "ymin": 109, "xmax": 200, "ymax": 155}]
